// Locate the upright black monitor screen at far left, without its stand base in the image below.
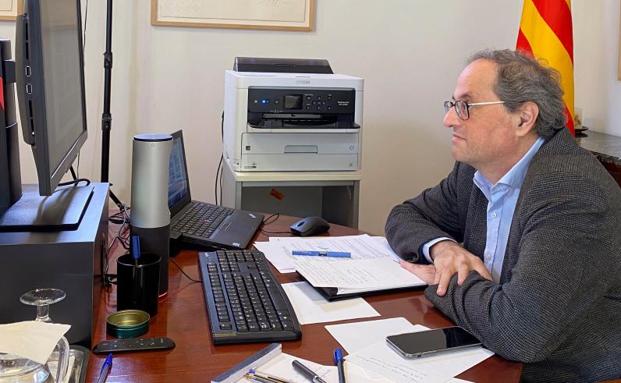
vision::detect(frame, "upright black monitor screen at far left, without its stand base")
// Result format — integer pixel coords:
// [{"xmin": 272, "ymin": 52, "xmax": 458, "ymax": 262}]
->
[{"xmin": 15, "ymin": 0, "xmax": 87, "ymax": 196}]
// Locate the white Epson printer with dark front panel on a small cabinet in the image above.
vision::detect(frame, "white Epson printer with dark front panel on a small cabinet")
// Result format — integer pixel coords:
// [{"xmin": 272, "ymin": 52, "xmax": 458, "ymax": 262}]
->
[{"xmin": 223, "ymin": 57, "xmax": 363, "ymax": 172}]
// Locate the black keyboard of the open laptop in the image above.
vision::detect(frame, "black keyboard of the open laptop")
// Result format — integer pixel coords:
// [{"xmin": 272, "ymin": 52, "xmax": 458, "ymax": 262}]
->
[{"xmin": 171, "ymin": 201, "xmax": 235, "ymax": 238}]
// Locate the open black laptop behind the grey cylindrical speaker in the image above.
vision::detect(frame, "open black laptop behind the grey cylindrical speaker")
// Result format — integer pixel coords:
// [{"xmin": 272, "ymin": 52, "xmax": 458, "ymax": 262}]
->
[{"xmin": 168, "ymin": 130, "xmax": 263, "ymax": 249}]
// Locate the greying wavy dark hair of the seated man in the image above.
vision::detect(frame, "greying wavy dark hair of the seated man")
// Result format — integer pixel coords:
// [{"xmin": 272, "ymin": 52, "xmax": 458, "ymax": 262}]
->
[{"xmin": 468, "ymin": 49, "xmax": 566, "ymax": 138}]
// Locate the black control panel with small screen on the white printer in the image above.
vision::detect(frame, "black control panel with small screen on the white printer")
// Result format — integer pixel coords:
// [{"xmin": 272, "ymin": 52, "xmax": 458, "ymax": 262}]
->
[{"xmin": 248, "ymin": 88, "xmax": 356, "ymax": 114}]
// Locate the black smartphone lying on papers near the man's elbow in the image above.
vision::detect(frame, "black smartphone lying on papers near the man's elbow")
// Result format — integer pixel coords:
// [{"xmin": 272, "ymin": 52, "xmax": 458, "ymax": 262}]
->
[{"xmin": 386, "ymin": 326, "xmax": 481, "ymax": 359}]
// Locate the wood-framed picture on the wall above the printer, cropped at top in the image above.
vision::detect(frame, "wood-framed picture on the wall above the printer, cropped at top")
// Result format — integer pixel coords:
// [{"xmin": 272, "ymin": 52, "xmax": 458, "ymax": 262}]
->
[{"xmin": 151, "ymin": 0, "xmax": 316, "ymax": 31}]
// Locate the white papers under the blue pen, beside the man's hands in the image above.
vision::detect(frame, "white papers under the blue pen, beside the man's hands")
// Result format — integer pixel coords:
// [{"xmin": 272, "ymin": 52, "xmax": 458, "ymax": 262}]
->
[{"xmin": 255, "ymin": 234, "xmax": 425, "ymax": 295}]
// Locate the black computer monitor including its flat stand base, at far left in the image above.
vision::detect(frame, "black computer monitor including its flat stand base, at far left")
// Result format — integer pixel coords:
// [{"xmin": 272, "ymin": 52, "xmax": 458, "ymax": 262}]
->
[{"xmin": 0, "ymin": 0, "xmax": 92, "ymax": 231}]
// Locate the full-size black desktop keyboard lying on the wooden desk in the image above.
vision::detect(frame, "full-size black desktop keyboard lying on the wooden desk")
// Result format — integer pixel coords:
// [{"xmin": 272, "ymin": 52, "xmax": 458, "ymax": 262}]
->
[{"xmin": 198, "ymin": 249, "xmax": 302, "ymax": 344}]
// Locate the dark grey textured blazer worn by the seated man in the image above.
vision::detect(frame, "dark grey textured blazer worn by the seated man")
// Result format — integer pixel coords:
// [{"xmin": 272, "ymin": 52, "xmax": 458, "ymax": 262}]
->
[{"xmin": 386, "ymin": 129, "xmax": 621, "ymax": 382}]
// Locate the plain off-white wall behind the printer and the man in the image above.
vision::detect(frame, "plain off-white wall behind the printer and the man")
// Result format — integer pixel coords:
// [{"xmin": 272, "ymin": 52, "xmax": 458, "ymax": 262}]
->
[{"xmin": 0, "ymin": 0, "xmax": 621, "ymax": 234}]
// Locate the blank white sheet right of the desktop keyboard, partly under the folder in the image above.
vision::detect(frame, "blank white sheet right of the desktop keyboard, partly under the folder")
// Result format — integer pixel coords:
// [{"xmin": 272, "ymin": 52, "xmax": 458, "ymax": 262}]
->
[{"xmin": 282, "ymin": 282, "xmax": 380, "ymax": 324}]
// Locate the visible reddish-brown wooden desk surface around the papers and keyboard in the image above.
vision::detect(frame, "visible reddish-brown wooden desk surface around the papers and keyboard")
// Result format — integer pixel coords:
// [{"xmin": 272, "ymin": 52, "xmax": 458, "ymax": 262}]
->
[{"xmin": 87, "ymin": 217, "xmax": 521, "ymax": 382}]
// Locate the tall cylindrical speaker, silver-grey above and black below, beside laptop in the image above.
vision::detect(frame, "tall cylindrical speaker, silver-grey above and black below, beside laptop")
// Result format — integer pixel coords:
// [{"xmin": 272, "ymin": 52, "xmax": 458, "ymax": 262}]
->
[{"xmin": 131, "ymin": 133, "xmax": 172, "ymax": 296}]
